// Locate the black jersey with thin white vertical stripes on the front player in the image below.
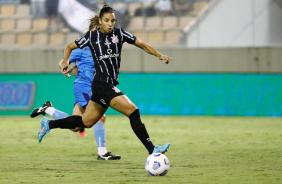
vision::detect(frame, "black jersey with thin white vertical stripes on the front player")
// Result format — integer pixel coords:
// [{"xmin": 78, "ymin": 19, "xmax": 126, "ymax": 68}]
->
[{"xmin": 75, "ymin": 28, "xmax": 136, "ymax": 85}]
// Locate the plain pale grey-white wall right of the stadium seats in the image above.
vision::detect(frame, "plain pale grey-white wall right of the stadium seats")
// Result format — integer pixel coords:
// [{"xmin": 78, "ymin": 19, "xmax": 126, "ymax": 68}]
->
[{"xmin": 186, "ymin": 0, "xmax": 282, "ymax": 47}]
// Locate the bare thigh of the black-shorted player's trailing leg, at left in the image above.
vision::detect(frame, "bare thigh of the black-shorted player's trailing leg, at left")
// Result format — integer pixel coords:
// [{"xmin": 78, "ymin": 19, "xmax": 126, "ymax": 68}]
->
[{"xmin": 82, "ymin": 100, "xmax": 107, "ymax": 128}]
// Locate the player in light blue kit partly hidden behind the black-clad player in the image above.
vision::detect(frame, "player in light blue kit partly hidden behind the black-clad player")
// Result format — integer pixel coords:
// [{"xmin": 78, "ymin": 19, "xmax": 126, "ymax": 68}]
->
[{"xmin": 30, "ymin": 20, "xmax": 121, "ymax": 160}]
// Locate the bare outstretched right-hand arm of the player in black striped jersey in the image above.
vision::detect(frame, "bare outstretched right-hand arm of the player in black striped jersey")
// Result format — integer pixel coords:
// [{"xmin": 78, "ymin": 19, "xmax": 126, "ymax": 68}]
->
[{"xmin": 133, "ymin": 38, "xmax": 172, "ymax": 64}]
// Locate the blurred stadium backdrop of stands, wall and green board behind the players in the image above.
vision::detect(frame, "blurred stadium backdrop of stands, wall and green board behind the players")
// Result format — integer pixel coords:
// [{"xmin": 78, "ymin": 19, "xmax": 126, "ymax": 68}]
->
[{"xmin": 0, "ymin": 0, "xmax": 282, "ymax": 116}]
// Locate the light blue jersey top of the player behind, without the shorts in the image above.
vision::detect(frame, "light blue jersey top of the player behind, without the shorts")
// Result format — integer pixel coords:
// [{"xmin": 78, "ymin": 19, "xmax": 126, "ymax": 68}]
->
[{"xmin": 70, "ymin": 47, "xmax": 95, "ymax": 86}]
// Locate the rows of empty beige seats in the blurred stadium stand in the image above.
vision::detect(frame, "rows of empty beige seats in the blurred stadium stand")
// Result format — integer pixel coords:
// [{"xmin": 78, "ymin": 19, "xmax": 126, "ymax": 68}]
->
[{"xmin": 0, "ymin": 0, "xmax": 212, "ymax": 47}]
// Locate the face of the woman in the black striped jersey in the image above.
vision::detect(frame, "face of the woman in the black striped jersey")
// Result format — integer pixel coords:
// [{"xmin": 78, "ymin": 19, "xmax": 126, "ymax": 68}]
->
[{"xmin": 99, "ymin": 13, "xmax": 116, "ymax": 34}]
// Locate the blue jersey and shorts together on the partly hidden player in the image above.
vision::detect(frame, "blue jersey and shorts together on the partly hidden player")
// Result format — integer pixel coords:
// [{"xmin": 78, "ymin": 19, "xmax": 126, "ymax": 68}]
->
[{"xmin": 70, "ymin": 47, "xmax": 95, "ymax": 108}]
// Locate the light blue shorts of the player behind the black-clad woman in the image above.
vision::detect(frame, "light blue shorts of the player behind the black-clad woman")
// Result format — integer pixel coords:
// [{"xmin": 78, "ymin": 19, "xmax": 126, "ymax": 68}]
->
[{"xmin": 73, "ymin": 83, "xmax": 92, "ymax": 109}]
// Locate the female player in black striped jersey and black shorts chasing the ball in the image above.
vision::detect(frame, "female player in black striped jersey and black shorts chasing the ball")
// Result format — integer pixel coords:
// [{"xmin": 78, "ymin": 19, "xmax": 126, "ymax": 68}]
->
[{"xmin": 38, "ymin": 4, "xmax": 172, "ymax": 154}]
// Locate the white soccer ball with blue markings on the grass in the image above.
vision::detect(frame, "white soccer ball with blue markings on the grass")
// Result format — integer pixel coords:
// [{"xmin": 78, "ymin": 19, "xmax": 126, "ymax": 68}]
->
[{"xmin": 145, "ymin": 153, "xmax": 170, "ymax": 176}]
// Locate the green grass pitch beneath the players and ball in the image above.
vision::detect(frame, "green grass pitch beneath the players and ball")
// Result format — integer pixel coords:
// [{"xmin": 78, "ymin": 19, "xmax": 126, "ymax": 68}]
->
[{"xmin": 0, "ymin": 116, "xmax": 282, "ymax": 184}]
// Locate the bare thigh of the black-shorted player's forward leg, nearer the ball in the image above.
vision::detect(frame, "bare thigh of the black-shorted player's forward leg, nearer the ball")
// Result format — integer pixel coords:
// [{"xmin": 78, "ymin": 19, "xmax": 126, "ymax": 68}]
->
[{"xmin": 110, "ymin": 95, "xmax": 137, "ymax": 117}]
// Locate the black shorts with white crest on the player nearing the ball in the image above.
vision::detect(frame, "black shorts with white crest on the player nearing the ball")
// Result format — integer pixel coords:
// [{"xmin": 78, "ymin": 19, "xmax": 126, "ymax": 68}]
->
[{"xmin": 91, "ymin": 80, "xmax": 124, "ymax": 109}]
